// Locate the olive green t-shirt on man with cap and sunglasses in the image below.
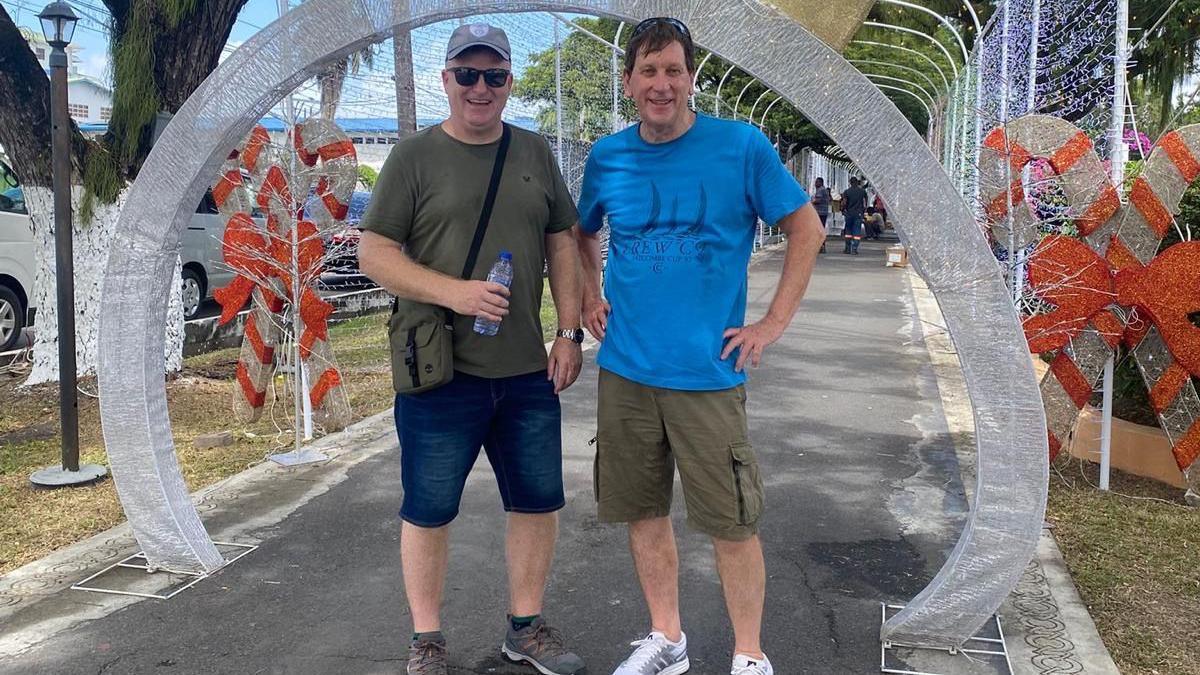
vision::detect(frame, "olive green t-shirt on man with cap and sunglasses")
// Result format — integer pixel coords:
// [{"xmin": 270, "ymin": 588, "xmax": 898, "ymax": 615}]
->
[{"xmin": 361, "ymin": 125, "xmax": 578, "ymax": 377}]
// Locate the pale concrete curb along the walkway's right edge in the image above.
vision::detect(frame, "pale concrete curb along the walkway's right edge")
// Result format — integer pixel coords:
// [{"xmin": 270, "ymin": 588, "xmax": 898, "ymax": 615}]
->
[{"xmin": 908, "ymin": 268, "xmax": 1121, "ymax": 675}]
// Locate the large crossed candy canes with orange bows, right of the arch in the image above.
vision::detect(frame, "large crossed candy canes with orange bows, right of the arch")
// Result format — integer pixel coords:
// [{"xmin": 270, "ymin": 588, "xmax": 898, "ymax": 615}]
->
[{"xmin": 986, "ymin": 115, "xmax": 1200, "ymax": 503}]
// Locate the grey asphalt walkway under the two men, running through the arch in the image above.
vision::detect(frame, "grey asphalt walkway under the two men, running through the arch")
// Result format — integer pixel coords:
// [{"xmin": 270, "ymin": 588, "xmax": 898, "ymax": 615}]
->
[{"xmin": 0, "ymin": 235, "xmax": 1108, "ymax": 675}]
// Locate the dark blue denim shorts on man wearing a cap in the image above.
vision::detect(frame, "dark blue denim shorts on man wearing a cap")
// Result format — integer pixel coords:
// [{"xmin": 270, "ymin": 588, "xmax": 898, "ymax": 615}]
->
[{"xmin": 395, "ymin": 371, "xmax": 565, "ymax": 527}]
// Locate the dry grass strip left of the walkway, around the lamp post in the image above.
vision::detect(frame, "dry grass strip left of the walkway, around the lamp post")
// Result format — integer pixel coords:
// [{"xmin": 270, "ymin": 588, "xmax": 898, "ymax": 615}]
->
[{"xmin": 0, "ymin": 315, "xmax": 392, "ymax": 574}]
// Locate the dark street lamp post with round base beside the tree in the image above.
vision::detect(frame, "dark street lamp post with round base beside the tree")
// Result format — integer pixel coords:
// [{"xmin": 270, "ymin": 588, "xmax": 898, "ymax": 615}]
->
[{"xmin": 29, "ymin": 0, "xmax": 108, "ymax": 488}]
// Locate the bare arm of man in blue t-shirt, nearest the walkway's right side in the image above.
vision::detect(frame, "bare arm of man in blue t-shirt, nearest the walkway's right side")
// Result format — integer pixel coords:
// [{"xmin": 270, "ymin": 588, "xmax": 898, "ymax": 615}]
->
[{"xmin": 721, "ymin": 204, "xmax": 824, "ymax": 371}]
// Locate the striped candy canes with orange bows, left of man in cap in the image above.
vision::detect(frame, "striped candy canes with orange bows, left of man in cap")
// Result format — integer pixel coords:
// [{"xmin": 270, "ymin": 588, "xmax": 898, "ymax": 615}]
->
[{"xmin": 214, "ymin": 120, "xmax": 356, "ymax": 428}]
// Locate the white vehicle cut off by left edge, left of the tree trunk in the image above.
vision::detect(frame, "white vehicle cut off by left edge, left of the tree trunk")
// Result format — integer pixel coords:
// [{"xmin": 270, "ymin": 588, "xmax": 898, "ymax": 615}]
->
[{"xmin": 0, "ymin": 183, "xmax": 37, "ymax": 352}]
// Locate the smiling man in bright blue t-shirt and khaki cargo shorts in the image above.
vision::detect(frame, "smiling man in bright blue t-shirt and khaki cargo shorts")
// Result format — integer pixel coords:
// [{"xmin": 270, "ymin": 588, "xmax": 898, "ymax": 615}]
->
[{"xmin": 578, "ymin": 18, "xmax": 824, "ymax": 675}]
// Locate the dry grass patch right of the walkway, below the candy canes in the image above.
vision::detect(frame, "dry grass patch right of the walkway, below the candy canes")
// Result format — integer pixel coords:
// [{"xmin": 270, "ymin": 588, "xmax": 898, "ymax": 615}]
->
[{"xmin": 1046, "ymin": 459, "xmax": 1200, "ymax": 675}]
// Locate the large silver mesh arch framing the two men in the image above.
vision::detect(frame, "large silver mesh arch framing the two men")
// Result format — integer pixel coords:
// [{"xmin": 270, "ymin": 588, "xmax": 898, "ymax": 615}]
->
[{"xmin": 100, "ymin": 0, "xmax": 1049, "ymax": 647}]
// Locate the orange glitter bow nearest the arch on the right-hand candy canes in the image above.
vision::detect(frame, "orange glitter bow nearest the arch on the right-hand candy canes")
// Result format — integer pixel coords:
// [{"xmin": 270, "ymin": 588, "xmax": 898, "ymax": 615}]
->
[{"xmin": 1022, "ymin": 235, "xmax": 1120, "ymax": 353}]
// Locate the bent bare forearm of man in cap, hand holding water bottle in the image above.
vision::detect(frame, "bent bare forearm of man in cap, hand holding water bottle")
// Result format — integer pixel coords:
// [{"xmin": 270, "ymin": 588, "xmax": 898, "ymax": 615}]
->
[{"xmin": 359, "ymin": 231, "xmax": 509, "ymax": 321}]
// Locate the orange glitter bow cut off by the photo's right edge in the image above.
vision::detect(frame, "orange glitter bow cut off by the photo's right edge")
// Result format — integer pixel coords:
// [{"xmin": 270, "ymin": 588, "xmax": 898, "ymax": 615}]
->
[{"xmin": 1116, "ymin": 241, "xmax": 1200, "ymax": 376}]
